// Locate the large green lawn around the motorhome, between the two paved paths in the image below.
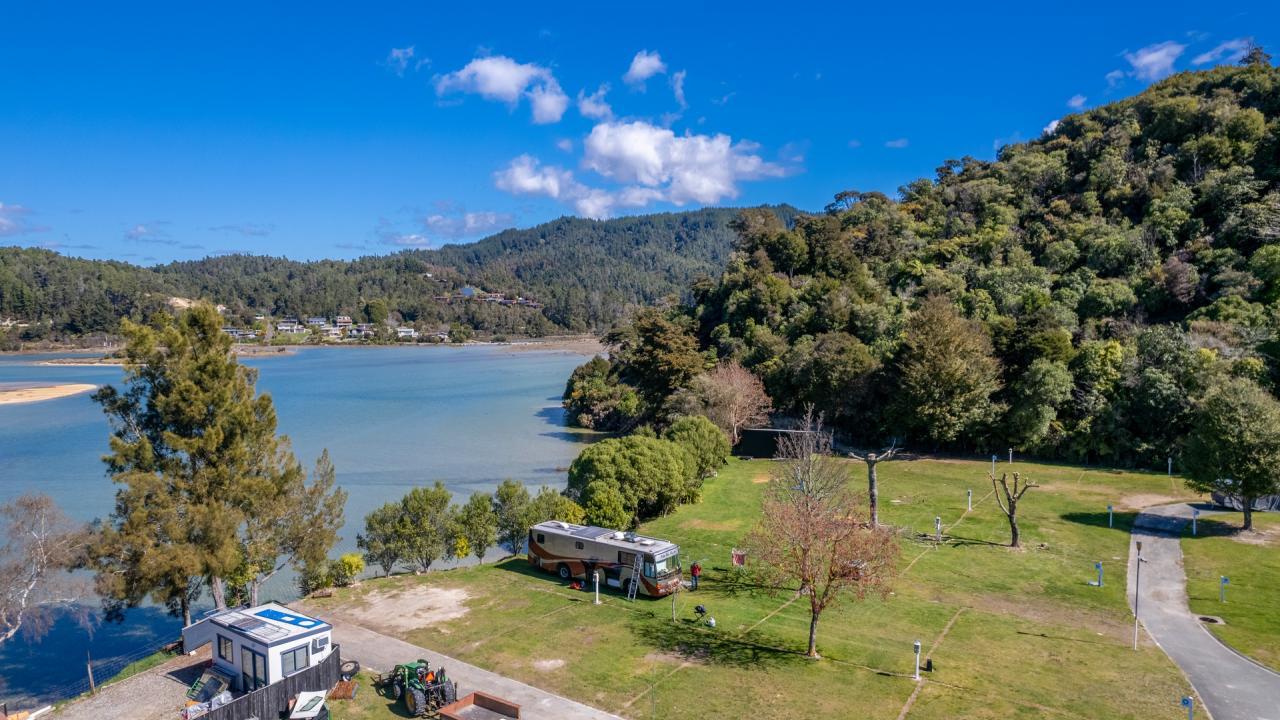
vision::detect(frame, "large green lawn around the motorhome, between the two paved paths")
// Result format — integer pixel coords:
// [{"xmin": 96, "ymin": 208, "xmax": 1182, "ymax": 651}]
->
[{"xmin": 312, "ymin": 460, "xmax": 1208, "ymax": 719}]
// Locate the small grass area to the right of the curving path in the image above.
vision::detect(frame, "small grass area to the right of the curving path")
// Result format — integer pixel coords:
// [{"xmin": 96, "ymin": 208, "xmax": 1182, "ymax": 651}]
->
[{"xmin": 1183, "ymin": 512, "xmax": 1280, "ymax": 670}]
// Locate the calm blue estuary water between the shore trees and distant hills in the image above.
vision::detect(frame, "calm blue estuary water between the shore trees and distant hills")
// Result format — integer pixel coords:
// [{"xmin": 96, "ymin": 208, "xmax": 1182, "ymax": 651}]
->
[{"xmin": 0, "ymin": 346, "xmax": 588, "ymax": 707}]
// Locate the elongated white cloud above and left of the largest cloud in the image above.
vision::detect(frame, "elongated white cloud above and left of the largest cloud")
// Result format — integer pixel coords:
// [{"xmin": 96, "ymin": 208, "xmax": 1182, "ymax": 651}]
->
[{"xmin": 435, "ymin": 55, "xmax": 568, "ymax": 124}]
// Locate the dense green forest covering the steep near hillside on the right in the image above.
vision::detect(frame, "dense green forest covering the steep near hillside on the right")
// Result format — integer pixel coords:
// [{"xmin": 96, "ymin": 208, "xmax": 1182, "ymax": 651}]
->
[{"xmin": 566, "ymin": 50, "xmax": 1280, "ymax": 466}]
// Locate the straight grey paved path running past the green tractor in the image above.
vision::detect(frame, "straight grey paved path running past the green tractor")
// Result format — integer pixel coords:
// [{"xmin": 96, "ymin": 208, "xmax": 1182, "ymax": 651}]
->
[{"xmin": 294, "ymin": 603, "xmax": 621, "ymax": 720}]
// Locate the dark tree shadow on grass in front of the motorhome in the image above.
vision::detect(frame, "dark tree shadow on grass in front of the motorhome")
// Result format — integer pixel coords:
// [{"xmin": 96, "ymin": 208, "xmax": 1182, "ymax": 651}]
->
[{"xmin": 628, "ymin": 609, "xmax": 808, "ymax": 669}]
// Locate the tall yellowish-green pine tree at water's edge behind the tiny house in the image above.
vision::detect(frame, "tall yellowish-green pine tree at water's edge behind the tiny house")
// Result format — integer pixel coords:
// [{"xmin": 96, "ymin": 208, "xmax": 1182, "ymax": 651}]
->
[{"xmin": 93, "ymin": 305, "xmax": 344, "ymax": 609}]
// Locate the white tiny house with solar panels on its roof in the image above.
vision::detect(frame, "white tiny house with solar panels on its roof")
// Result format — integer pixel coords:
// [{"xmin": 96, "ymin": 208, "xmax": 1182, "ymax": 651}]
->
[{"xmin": 182, "ymin": 602, "xmax": 333, "ymax": 692}]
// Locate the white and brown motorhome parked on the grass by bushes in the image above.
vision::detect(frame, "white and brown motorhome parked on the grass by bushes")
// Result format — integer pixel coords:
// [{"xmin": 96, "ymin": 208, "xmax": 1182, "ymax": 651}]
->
[{"xmin": 529, "ymin": 520, "xmax": 681, "ymax": 597}]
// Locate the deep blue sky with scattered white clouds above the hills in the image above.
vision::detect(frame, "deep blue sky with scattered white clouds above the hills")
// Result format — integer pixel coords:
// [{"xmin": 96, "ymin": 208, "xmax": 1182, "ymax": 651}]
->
[{"xmin": 0, "ymin": 1, "xmax": 1280, "ymax": 264}]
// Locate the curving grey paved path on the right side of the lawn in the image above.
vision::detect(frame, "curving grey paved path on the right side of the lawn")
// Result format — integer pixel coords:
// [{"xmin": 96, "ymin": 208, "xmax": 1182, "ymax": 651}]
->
[{"xmin": 1129, "ymin": 503, "xmax": 1280, "ymax": 720}]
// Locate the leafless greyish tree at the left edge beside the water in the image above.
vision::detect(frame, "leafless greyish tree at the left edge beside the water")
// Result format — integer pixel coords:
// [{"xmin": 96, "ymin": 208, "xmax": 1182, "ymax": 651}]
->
[{"xmin": 0, "ymin": 495, "xmax": 88, "ymax": 643}]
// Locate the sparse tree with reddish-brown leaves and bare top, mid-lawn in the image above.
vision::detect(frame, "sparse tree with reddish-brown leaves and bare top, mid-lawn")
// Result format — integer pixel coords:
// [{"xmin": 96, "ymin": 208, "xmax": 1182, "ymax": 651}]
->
[{"xmin": 748, "ymin": 414, "xmax": 899, "ymax": 659}]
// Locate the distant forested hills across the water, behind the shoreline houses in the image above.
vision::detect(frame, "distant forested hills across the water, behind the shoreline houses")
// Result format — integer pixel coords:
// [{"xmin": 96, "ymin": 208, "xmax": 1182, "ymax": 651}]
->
[{"xmin": 0, "ymin": 208, "xmax": 795, "ymax": 337}]
